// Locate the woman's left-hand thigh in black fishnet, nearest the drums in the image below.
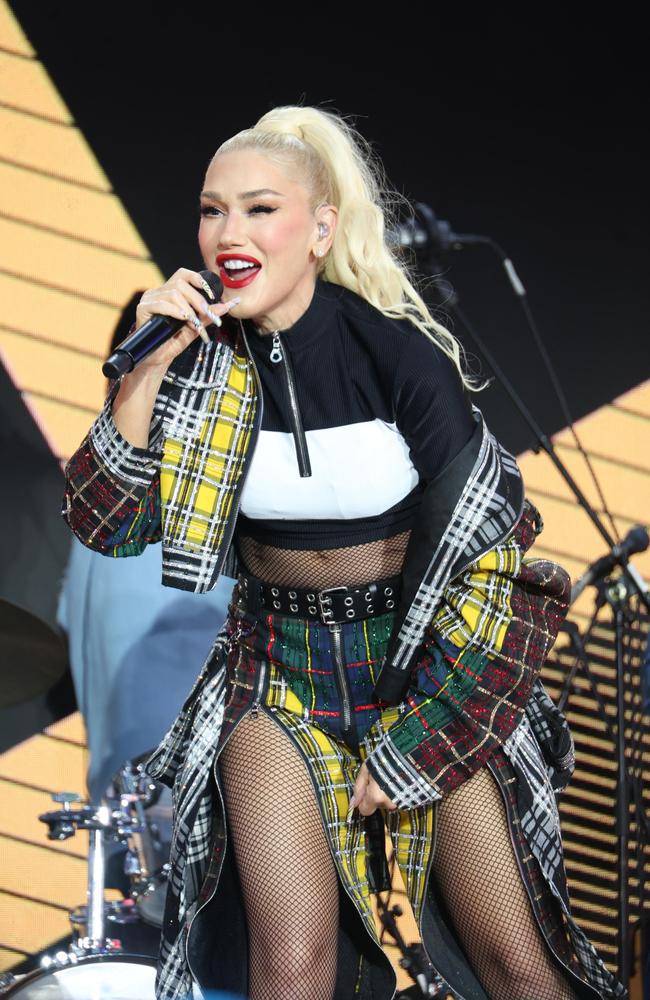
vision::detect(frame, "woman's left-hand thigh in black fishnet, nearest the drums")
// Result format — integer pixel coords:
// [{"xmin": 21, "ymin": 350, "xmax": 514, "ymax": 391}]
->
[{"xmin": 219, "ymin": 712, "xmax": 338, "ymax": 1000}]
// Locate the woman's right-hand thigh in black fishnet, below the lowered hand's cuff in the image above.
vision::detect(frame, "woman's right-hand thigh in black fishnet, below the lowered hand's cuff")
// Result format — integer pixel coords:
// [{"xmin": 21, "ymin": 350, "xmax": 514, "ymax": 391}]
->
[{"xmin": 433, "ymin": 767, "xmax": 575, "ymax": 1000}]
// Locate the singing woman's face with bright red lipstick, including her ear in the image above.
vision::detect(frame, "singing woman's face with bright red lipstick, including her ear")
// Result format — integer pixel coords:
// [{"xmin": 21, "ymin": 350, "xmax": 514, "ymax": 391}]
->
[{"xmin": 199, "ymin": 150, "xmax": 336, "ymax": 332}]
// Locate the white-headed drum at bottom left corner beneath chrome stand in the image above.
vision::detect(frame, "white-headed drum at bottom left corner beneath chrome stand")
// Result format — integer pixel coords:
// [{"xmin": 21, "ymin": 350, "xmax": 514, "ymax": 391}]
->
[{"xmin": 2, "ymin": 953, "xmax": 156, "ymax": 1000}]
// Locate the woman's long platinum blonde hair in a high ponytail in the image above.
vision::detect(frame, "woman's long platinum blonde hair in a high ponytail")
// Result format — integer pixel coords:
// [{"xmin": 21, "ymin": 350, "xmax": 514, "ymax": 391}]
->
[{"xmin": 215, "ymin": 106, "xmax": 476, "ymax": 389}]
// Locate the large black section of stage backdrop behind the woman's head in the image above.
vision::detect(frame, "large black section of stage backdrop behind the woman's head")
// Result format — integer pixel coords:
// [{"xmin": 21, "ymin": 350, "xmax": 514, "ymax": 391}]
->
[{"xmin": 11, "ymin": 7, "xmax": 650, "ymax": 452}]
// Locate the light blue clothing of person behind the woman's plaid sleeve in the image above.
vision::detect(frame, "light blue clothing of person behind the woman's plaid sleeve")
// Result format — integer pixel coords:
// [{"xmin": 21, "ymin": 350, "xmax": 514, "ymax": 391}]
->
[{"xmin": 57, "ymin": 538, "xmax": 234, "ymax": 802}]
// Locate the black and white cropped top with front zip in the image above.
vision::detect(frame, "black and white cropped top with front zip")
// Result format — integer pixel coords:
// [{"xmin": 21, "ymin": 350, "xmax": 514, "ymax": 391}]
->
[{"xmin": 237, "ymin": 279, "xmax": 474, "ymax": 549}]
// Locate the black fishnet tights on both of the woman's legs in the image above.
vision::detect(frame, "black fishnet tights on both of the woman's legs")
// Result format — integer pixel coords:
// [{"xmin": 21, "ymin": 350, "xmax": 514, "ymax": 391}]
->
[{"xmin": 219, "ymin": 712, "xmax": 576, "ymax": 1000}]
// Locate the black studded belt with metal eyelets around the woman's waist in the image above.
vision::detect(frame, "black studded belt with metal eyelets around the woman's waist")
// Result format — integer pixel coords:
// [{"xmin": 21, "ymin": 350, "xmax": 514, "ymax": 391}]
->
[{"xmin": 238, "ymin": 573, "xmax": 401, "ymax": 625}]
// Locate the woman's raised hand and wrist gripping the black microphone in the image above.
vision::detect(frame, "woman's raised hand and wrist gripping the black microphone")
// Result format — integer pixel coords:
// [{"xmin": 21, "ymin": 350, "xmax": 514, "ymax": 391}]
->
[{"xmin": 129, "ymin": 267, "xmax": 239, "ymax": 377}]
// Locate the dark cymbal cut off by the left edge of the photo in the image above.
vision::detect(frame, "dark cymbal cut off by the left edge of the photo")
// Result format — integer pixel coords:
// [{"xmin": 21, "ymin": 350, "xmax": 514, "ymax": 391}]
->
[{"xmin": 0, "ymin": 598, "xmax": 68, "ymax": 708}]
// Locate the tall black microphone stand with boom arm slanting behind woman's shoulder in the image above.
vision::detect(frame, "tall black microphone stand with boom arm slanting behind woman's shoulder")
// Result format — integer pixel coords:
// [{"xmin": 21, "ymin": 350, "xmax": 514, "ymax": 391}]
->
[{"xmin": 417, "ymin": 240, "xmax": 650, "ymax": 989}]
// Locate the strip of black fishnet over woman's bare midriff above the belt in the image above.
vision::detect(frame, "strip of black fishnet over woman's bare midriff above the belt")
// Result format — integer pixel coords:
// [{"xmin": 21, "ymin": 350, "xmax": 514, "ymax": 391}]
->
[{"xmin": 237, "ymin": 530, "xmax": 411, "ymax": 589}]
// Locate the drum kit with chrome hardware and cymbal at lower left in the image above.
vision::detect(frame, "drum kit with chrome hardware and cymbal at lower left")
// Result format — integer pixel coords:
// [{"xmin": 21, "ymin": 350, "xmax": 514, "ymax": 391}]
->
[{"xmin": 0, "ymin": 600, "xmax": 172, "ymax": 1000}]
